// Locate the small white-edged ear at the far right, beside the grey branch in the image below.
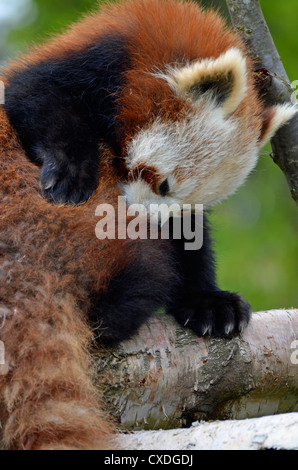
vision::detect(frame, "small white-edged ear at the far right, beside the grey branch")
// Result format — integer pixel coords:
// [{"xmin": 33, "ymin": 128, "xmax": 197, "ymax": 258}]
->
[{"xmin": 259, "ymin": 104, "xmax": 298, "ymax": 147}]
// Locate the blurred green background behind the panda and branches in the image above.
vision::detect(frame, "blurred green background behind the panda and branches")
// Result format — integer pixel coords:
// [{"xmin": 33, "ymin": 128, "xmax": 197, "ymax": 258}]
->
[{"xmin": 0, "ymin": 0, "xmax": 298, "ymax": 311}]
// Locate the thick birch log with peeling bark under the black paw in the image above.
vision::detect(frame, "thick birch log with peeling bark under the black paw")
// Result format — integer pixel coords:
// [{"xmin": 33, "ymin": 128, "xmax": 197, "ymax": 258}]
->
[{"xmin": 96, "ymin": 310, "xmax": 298, "ymax": 430}]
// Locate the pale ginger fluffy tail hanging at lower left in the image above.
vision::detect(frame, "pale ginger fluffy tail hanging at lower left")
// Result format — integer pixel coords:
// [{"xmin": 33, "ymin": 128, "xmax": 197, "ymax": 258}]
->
[{"xmin": 0, "ymin": 276, "xmax": 114, "ymax": 450}]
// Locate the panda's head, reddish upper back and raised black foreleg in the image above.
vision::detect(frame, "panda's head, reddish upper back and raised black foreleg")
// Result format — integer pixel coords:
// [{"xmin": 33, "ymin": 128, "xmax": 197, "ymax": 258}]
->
[{"xmin": 5, "ymin": 0, "xmax": 295, "ymax": 207}]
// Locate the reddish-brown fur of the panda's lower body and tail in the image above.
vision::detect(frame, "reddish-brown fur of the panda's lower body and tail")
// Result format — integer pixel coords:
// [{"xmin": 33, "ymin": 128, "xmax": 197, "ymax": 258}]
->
[{"xmin": 0, "ymin": 105, "xmax": 172, "ymax": 449}]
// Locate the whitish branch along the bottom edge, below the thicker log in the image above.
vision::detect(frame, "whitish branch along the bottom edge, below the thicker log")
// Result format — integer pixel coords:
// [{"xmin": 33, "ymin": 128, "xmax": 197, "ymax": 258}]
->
[{"xmin": 120, "ymin": 413, "xmax": 298, "ymax": 451}]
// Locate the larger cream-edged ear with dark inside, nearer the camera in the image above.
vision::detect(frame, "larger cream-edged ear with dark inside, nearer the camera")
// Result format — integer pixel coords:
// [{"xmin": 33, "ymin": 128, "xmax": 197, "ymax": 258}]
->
[{"xmin": 158, "ymin": 48, "xmax": 247, "ymax": 114}]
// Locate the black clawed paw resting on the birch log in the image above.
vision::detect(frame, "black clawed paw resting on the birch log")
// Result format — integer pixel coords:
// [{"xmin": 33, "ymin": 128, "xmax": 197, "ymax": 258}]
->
[{"xmin": 169, "ymin": 291, "xmax": 251, "ymax": 337}]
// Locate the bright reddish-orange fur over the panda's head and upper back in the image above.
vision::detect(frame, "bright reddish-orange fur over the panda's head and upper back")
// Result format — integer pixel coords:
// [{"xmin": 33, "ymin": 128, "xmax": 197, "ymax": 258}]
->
[{"xmin": 7, "ymin": 0, "xmax": 263, "ymax": 148}]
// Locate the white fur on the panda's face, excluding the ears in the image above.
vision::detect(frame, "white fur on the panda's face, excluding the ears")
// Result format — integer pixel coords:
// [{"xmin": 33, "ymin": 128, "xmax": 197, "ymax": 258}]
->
[{"xmin": 123, "ymin": 99, "xmax": 258, "ymax": 207}]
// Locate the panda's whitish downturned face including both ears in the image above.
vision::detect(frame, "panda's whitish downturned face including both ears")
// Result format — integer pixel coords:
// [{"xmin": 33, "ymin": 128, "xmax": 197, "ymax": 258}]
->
[{"xmin": 122, "ymin": 49, "xmax": 294, "ymax": 216}]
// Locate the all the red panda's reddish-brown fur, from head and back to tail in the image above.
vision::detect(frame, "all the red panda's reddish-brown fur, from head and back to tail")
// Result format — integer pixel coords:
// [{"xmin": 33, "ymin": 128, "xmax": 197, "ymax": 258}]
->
[{"xmin": 0, "ymin": 0, "xmax": 278, "ymax": 449}]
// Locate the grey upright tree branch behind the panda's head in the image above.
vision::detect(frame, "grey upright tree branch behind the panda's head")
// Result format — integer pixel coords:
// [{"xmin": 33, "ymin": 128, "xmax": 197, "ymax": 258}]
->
[{"xmin": 226, "ymin": 0, "xmax": 298, "ymax": 204}]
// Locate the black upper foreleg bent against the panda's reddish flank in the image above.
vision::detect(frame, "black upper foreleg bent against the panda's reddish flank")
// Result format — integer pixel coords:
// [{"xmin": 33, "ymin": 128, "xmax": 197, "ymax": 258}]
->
[{"xmin": 5, "ymin": 36, "xmax": 128, "ymax": 203}]
